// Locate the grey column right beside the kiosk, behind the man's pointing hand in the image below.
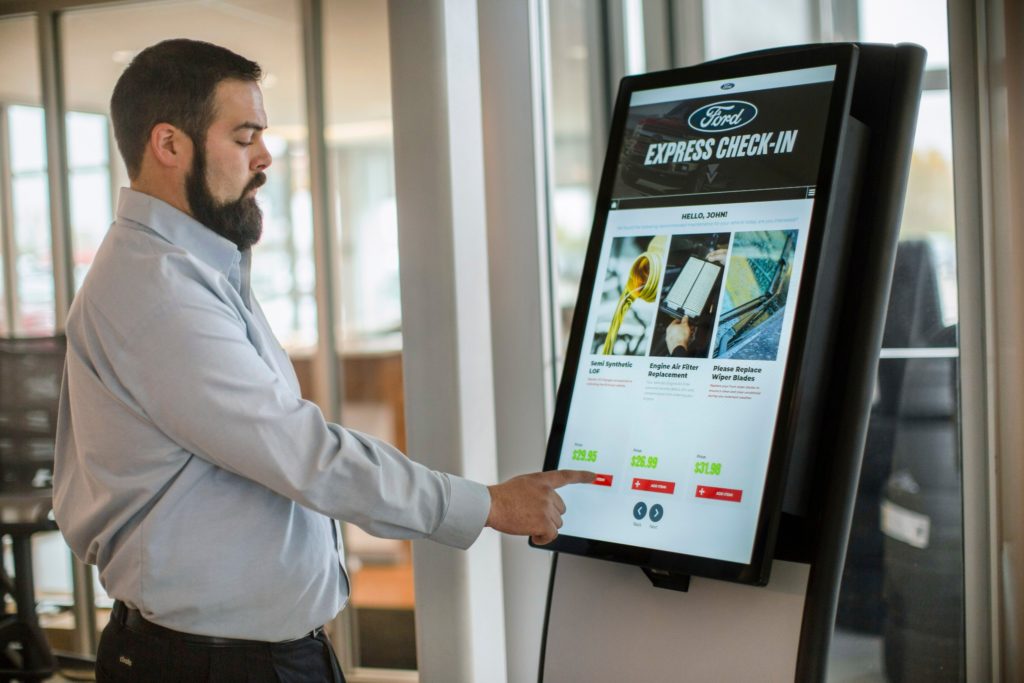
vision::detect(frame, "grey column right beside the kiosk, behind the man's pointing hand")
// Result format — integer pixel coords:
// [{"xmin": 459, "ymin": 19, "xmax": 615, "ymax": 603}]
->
[{"xmin": 479, "ymin": 0, "xmax": 554, "ymax": 683}]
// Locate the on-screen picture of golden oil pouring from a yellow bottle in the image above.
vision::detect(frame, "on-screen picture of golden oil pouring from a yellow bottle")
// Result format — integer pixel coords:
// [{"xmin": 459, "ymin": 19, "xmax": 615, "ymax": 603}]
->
[{"xmin": 591, "ymin": 234, "xmax": 669, "ymax": 355}]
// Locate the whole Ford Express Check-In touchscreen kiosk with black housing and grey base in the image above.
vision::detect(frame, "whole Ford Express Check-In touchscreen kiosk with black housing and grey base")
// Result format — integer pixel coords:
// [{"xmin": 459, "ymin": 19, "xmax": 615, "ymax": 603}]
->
[{"xmin": 540, "ymin": 43, "xmax": 925, "ymax": 681}]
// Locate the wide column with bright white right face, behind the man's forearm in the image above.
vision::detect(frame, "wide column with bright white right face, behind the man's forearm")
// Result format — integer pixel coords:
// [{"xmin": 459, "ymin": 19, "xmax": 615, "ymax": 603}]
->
[{"xmin": 388, "ymin": 0, "xmax": 506, "ymax": 683}]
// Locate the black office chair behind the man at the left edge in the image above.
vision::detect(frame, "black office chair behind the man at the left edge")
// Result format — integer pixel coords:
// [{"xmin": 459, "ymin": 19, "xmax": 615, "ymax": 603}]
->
[{"xmin": 0, "ymin": 337, "xmax": 67, "ymax": 681}]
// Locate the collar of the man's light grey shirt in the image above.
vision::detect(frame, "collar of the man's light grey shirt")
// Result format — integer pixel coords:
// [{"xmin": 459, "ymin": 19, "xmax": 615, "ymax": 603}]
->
[{"xmin": 118, "ymin": 187, "xmax": 241, "ymax": 275}]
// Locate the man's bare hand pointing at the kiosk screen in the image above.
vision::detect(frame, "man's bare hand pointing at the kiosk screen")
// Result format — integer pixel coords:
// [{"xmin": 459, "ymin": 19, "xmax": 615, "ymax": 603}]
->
[{"xmin": 487, "ymin": 470, "xmax": 594, "ymax": 546}]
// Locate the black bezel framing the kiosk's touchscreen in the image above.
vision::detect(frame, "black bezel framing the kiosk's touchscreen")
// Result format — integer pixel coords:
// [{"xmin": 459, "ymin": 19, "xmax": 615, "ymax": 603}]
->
[{"xmin": 530, "ymin": 43, "xmax": 858, "ymax": 585}]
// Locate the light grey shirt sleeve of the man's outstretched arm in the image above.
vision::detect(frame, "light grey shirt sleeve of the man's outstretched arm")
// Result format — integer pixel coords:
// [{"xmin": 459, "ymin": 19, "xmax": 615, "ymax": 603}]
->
[{"xmin": 119, "ymin": 293, "xmax": 490, "ymax": 548}]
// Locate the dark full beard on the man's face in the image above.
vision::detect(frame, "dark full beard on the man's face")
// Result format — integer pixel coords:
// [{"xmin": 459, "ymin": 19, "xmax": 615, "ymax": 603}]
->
[{"xmin": 185, "ymin": 142, "xmax": 266, "ymax": 251}]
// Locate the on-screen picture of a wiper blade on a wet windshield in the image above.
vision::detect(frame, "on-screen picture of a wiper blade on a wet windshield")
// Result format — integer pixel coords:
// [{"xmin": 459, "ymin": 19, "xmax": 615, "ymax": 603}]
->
[{"xmin": 714, "ymin": 230, "xmax": 797, "ymax": 360}]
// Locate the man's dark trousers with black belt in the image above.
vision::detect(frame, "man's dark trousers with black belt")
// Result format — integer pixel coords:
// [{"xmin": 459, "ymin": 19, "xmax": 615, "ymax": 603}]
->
[{"xmin": 96, "ymin": 608, "xmax": 345, "ymax": 683}]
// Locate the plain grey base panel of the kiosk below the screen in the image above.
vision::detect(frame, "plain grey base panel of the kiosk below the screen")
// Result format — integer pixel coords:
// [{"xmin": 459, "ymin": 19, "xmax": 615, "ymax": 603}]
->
[{"xmin": 541, "ymin": 553, "xmax": 811, "ymax": 683}]
